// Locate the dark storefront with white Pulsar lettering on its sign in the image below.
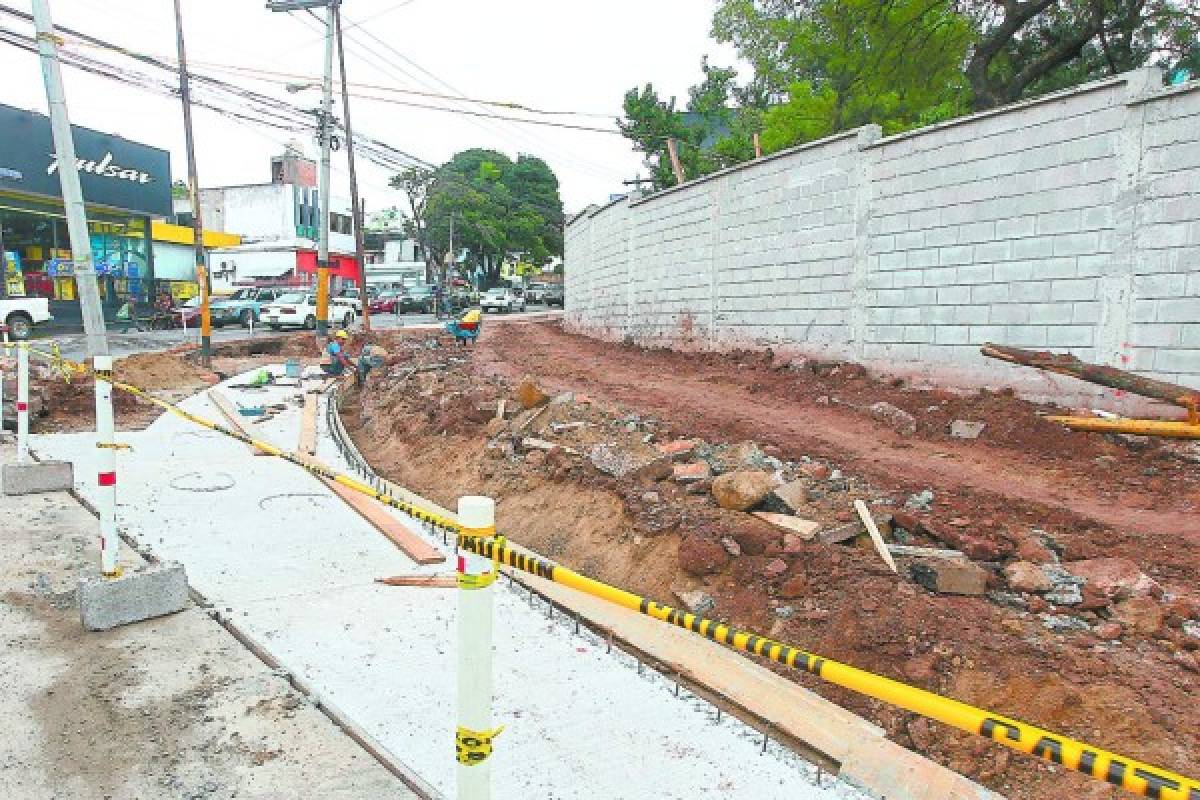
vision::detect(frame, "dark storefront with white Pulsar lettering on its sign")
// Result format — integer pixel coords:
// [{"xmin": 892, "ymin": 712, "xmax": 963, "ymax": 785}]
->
[{"xmin": 0, "ymin": 106, "xmax": 172, "ymax": 323}]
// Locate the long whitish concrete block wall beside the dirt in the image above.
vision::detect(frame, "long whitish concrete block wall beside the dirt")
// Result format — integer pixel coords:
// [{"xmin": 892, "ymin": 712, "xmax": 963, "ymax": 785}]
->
[{"xmin": 566, "ymin": 70, "xmax": 1200, "ymax": 396}]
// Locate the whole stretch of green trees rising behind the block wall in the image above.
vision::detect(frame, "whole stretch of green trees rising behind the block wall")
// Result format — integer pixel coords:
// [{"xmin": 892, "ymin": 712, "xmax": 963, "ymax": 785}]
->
[{"xmin": 618, "ymin": 0, "xmax": 1200, "ymax": 187}]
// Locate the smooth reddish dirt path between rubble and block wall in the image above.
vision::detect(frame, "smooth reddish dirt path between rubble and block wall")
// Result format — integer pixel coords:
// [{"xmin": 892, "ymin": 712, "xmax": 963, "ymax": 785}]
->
[{"xmin": 479, "ymin": 325, "xmax": 1200, "ymax": 545}]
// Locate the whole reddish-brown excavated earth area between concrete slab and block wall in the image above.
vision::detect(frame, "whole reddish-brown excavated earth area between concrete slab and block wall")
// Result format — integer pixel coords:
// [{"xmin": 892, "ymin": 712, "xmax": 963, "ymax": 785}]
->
[{"xmin": 346, "ymin": 325, "xmax": 1200, "ymax": 800}]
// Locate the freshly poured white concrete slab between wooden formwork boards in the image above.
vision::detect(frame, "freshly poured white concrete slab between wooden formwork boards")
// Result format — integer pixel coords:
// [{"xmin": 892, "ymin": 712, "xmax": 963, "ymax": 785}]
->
[{"xmin": 34, "ymin": 369, "xmax": 865, "ymax": 800}]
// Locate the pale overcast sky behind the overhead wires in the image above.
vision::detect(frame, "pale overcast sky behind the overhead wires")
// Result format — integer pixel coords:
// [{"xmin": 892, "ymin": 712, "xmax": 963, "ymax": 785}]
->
[{"xmin": 0, "ymin": 0, "xmax": 733, "ymax": 213}]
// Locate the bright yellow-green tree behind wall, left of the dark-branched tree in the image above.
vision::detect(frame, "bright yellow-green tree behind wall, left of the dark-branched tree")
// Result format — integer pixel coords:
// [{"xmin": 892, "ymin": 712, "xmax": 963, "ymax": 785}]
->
[{"xmin": 713, "ymin": 0, "xmax": 973, "ymax": 151}]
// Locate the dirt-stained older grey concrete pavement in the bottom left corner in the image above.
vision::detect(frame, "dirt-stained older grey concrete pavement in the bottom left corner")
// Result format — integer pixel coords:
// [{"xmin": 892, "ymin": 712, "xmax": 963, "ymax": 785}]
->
[{"xmin": 0, "ymin": 444, "xmax": 413, "ymax": 800}]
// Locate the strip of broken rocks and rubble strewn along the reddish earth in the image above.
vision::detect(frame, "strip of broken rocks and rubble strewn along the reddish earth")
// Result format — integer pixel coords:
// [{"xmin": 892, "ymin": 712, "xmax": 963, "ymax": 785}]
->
[{"xmin": 446, "ymin": 369, "xmax": 1200, "ymax": 668}]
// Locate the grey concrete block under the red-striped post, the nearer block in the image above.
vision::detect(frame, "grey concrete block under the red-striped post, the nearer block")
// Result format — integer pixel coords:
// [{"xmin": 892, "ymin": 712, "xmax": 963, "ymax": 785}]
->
[{"xmin": 79, "ymin": 561, "xmax": 187, "ymax": 631}]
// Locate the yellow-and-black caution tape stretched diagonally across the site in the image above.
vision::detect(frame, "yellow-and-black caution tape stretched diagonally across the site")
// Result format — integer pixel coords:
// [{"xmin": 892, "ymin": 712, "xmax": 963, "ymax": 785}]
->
[{"xmin": 18, "ymin": 340, "xmax": 1200, "ymax": 800}]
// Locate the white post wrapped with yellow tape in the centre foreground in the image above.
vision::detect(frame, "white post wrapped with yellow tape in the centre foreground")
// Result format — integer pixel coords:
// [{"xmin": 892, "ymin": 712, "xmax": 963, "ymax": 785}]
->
[{"xmin": 455, "ymin": 497, "xmax": 498, "ymax": 800}]
